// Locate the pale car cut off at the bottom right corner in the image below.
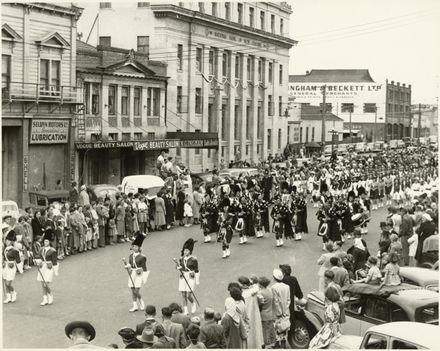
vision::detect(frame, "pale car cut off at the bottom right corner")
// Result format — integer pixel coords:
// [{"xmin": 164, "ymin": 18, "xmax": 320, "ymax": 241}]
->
[{"xmin": 328, "ymin": 322, "xmax": 438, "ymax": 350}]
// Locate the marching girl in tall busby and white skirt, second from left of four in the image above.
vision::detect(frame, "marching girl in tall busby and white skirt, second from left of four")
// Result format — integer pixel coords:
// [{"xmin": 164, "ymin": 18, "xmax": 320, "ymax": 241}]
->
[{"xmin": 35, "ymin": 228, "xmax": 59, "ymax": 306}]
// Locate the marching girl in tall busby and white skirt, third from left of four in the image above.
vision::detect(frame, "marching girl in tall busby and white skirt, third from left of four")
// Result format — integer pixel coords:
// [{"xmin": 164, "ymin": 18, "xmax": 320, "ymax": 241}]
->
[{"xmin": 125, "ymin": 232, "xmax": 150, "ymax": 312}]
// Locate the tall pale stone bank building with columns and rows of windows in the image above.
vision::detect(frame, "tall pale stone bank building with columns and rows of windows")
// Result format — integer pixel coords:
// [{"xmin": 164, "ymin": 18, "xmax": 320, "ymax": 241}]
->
[{"xmin": 94, "ymin": 2, "xmax": 296, "ymax": 171}]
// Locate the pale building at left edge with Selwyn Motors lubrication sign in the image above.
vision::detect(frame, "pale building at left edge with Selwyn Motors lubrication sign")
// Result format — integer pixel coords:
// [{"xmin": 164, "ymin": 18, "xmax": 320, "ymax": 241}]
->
[{"xmin": 1, "ymin": 3, "xmax": 82, "ymax": 207}]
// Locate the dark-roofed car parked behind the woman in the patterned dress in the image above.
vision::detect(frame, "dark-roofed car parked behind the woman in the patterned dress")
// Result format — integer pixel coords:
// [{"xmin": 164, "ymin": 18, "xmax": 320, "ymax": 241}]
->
[{"xmin": 300, "ymin": 283, "xmax": 439, "ymax": 348}]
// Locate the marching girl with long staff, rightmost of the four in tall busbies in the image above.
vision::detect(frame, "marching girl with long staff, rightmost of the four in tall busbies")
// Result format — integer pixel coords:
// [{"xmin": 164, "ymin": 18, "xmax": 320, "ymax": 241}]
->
[{"xmin": 177, "ymin": 238, "xmax": 200, "ymax": 314}]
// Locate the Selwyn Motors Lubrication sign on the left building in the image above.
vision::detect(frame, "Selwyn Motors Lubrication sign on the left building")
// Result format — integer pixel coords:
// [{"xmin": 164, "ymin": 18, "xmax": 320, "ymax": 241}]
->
[{"xmin": 29, "ymin": 119, "xmax": 69, "ymax": 144}]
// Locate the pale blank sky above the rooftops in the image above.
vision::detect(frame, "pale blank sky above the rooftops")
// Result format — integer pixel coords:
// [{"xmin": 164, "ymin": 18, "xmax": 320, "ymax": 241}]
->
[{"xmin": 77, "ymin": 0, "xmax": 440, "ymax": 104}]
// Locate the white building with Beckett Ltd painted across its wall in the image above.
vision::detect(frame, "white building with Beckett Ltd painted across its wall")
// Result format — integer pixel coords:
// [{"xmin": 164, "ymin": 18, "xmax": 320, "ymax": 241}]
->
[{"xmin": 289, "ymin": 69, "xmax": 388, "ymax": 142}]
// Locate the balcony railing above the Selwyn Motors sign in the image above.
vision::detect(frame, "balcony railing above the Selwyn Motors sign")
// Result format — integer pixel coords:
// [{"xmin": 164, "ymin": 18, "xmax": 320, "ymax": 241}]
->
[{"xmin": 2, "ymin": 82, "xmax": 82, "ymax": 104}]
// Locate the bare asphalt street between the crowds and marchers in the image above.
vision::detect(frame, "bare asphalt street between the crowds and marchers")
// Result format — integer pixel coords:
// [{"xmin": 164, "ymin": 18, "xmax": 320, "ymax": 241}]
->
[{"xmin": 3, "ymin": 204, "xmax": 386, "ymax": 348}]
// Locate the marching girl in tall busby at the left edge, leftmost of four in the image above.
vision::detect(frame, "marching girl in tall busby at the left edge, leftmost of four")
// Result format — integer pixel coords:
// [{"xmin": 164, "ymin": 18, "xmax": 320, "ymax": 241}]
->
[{"xmin": 3, "ymin": 230, "xmax": 23, "ymax": 303}]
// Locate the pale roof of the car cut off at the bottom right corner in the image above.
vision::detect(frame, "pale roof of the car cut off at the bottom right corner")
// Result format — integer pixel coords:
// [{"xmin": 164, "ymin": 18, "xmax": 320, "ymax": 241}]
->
[{"xmin": 367, "ymin": 322, "xmax": 438, "ymax": 349}]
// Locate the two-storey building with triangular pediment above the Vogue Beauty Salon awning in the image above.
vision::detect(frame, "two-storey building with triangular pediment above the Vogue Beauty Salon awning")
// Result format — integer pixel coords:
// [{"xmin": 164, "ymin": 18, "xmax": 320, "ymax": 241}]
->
[{"xmin": 76, "ymin": 41, "xmax": 168, "ymax": 185}]
